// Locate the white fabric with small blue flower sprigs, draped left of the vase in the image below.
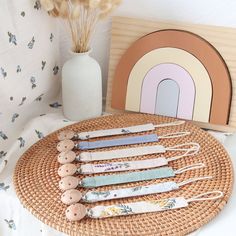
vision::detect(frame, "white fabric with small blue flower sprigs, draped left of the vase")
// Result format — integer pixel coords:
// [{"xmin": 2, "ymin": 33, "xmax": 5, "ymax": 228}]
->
[{"xmin": 0, "ymin": 0, "xmax": 70, "ymax": 236}]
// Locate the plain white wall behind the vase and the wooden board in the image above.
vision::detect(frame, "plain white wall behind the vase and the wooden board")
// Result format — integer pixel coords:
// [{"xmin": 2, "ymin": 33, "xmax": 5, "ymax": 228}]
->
[{"xmin": 61, "ymin": 0, "xmax": 236, "ymax": 96}]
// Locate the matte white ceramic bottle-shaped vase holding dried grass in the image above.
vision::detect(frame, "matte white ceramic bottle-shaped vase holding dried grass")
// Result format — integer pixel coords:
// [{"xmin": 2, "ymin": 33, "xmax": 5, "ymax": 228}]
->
[{"xmin": 62, "ymin": 51, "xmax": 102, "ymax": 121}]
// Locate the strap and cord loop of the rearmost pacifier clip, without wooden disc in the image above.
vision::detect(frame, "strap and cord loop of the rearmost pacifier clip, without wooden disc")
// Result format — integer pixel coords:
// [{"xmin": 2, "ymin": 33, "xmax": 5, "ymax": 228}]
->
[{"xmin": 76, "ymin": 121, "xmax": 185, "ymax": 140}]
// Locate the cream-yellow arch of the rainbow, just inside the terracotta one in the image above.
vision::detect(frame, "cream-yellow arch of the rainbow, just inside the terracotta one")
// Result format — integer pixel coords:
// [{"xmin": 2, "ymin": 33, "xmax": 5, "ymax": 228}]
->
[{"xmin": 125, "ymin": 48, "xmax": 212, "ymax": 122}]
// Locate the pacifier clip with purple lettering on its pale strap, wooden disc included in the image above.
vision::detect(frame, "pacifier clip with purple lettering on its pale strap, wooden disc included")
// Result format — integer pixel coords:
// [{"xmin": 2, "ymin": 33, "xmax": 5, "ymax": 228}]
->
[{"xmin": 58, "ymin": 143, "xmax": 200, "ymax": 177}]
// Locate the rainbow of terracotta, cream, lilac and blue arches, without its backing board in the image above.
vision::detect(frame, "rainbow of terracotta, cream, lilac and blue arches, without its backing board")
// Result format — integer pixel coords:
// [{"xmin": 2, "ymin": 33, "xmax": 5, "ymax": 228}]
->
[{"xmin": 112, "ymin": 30, "xmax": 232, "ymax": 125}]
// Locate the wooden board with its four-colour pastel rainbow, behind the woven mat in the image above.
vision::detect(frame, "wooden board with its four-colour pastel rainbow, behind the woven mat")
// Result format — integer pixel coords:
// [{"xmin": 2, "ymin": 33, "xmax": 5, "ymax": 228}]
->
[{"xmin": 107, "ymin": 17, "xmax": 236, "ymax": 131}]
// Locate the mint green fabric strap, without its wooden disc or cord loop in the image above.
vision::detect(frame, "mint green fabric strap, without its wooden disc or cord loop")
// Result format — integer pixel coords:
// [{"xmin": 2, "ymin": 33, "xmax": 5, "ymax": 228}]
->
[{"xmin": 81, "ymin": 167, "xmax": 175, "ymax": 188}]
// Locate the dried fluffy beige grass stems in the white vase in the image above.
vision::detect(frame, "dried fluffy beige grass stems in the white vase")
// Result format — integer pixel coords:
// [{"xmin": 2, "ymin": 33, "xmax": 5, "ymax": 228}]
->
[{"xmin": 40, "ymin": 0, "xmax": 122, "ymax": 53}]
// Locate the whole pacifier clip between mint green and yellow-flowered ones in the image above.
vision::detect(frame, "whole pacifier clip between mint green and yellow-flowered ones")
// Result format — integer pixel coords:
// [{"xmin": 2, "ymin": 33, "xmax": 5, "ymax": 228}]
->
[{"xmin": 61, "ymin": 176, "xmax": 212, "ymax": 205}]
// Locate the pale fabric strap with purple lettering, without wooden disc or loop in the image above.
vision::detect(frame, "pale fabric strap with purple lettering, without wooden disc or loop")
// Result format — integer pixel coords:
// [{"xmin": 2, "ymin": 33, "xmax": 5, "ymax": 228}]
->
[{"xmin": 78, "ymin": 157, "xmax": 168, "ymax": 174}]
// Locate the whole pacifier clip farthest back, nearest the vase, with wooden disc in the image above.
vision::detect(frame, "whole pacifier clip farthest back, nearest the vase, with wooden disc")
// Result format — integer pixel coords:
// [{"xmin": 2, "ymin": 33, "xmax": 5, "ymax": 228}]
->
[{"xmin": 58, "ymin": 120, "xmax": 185, "ymax": 141}]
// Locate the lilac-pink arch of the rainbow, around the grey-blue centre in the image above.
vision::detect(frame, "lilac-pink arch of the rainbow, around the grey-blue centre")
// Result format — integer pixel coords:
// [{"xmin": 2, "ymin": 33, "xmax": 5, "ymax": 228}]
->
[{"xmin": 140, "ymin": 63, "xmax": 195, "ymax": 120}]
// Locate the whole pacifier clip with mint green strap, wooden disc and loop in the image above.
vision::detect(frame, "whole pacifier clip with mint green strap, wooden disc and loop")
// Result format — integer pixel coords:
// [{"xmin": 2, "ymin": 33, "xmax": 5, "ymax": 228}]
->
[{"xmin": 59, "ymin": 163, "xmax": 205, "ymax": 191}]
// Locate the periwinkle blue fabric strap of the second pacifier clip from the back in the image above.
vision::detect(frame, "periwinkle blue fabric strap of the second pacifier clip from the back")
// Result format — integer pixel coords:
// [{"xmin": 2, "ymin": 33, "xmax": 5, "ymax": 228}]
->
[{"xmin": 75, "ymin": 134, "xmax": 158, "ymax": 150}]
